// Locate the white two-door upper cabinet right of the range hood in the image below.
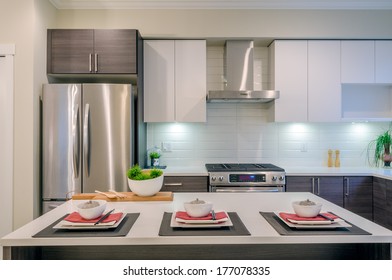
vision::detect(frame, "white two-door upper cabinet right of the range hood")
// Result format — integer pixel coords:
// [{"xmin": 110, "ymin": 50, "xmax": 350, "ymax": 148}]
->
[{"xmin": 271, "ymin": 40, "xmax": 341, "ymax": 122}]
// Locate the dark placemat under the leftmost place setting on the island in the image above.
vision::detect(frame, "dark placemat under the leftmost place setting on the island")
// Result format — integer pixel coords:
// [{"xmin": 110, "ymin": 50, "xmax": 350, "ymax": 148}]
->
[{"xmin": 32, "ymin": 213, "xmax": 140, "ymax": 237}]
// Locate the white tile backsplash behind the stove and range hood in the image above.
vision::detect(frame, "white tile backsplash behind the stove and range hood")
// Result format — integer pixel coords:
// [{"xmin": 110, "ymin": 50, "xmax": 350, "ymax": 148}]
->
[{"xmin": 147, "ymin": 47, "xmax": 389, "ymax": 167}]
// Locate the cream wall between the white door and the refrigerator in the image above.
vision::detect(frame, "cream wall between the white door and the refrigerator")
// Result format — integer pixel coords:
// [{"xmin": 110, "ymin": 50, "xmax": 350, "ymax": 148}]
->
[{"xmin": 0, "ymin": 0, "xmax": 55, "ymax": 229}]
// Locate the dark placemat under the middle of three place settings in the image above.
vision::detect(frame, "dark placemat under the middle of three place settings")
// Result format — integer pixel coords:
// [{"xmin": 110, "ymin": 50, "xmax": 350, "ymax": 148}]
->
[{"xmin": 159, "ymin": 212, "xmax": 250, "ymax": 236}]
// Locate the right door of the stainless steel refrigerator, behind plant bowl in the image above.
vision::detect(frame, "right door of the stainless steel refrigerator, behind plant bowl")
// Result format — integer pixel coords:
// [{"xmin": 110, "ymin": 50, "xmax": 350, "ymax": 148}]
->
[{"xmin": 82, "ymin": 84, "xmax": 134, "ymax": 192}]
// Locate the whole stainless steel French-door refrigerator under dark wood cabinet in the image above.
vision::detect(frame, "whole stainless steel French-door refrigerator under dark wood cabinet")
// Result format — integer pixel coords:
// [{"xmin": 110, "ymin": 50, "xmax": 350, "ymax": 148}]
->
[{"xmin": 41, "ymin": 84, "xmax": 138, "ymax": 213}]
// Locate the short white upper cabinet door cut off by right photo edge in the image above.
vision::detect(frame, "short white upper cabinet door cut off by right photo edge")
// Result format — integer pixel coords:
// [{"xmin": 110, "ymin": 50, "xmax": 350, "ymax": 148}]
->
[{"xmin": 375, "ymin": 41, "xmax": 392, "ymax": 83}]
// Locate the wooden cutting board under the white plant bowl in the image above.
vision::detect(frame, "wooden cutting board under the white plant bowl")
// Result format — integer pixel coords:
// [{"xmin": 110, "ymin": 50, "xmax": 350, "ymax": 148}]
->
[{"xmin": 72, "ymin": 192, "xmax": 173, "ymax": 202}]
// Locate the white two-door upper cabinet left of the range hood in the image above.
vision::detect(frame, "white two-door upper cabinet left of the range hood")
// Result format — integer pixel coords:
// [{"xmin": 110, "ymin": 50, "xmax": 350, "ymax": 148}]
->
[{"xmin": 144, "ymin": 40, "xmax": 207, "ymax": 122}]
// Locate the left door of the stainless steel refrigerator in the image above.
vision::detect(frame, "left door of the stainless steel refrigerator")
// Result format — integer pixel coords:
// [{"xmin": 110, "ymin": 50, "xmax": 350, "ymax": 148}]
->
[{"xmin": 42, "ymin": 84, "xmax": 82, "ymax": 200}]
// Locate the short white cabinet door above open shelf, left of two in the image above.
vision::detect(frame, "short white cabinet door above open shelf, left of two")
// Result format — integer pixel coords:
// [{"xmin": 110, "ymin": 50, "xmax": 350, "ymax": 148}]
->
[{"xmin": 341, "ymin": 41, "xmax": 375, "ymax": 84}]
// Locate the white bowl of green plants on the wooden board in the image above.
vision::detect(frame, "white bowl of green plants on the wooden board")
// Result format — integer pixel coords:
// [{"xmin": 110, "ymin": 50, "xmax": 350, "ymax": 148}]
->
[{"xmin": 127, "ymin": 164, "xmax": 163, "ymax": 196}]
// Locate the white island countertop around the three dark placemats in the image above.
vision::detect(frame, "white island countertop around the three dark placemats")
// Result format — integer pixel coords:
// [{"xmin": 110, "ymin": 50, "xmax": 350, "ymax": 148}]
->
[{"xmin": 0, "ymin": 193, "xmax": 392, "ymax": 259}]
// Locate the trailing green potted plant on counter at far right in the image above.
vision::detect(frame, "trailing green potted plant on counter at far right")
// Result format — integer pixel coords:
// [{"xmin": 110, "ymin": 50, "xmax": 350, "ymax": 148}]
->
[{"xmin": 367, "ymin": 126, "xmax": 392, "ymax": 167}]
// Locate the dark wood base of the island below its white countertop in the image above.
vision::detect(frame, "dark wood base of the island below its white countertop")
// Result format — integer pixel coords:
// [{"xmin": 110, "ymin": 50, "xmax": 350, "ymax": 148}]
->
[{"xmin": 5, "ymin": 243, "xmax": 391, "ymax": 260}]
